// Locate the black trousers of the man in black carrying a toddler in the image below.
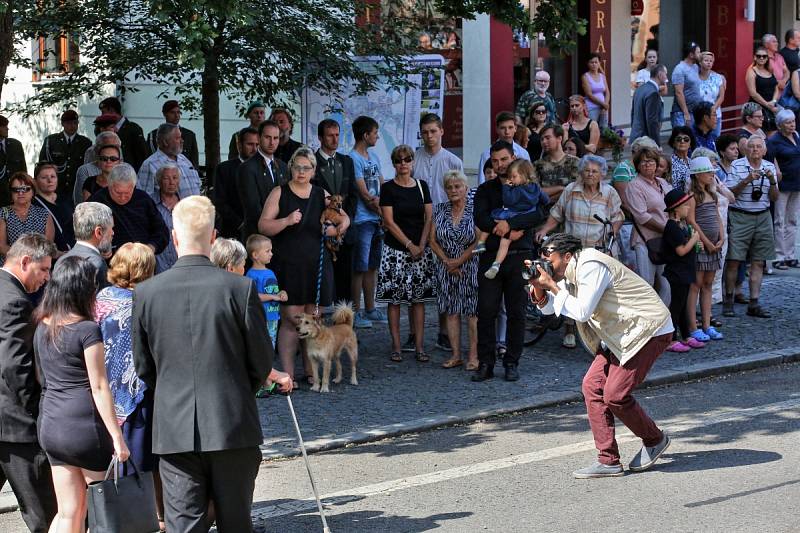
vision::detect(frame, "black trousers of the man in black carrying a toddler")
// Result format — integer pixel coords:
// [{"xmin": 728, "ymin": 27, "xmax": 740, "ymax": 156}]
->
[{"xmin": 478, "ymin": 250, "xmax": 533, "ymax": 366}]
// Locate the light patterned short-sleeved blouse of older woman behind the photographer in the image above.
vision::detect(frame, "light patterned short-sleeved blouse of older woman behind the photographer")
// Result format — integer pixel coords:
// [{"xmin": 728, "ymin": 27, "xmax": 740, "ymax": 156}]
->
[{"xmin": 550, "ymin": 182, "xmax": 624, "ymax": 248}]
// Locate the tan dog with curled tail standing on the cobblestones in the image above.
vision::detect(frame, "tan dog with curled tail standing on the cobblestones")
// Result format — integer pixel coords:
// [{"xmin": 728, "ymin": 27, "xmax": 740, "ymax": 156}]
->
[{"xmin": 295, "ymin": 302, "xmax": 358, "ymax": 392}]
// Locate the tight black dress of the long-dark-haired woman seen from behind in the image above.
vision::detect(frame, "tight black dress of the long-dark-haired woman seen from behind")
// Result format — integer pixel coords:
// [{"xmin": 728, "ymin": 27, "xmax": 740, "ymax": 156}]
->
[{"xmin": 34, "ymin": 320, "xmax": 114, "ymax": 471}]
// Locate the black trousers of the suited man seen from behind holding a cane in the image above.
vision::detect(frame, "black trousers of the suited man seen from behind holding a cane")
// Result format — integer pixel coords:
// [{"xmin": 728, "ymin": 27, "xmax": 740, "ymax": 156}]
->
[{"xmin": 158, "ymin": 446, "xmax": 261, "ymax": 533}]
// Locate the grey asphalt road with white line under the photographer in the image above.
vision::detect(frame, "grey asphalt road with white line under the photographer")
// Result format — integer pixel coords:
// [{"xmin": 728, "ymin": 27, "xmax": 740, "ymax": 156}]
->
[{"xmin": 0, "ymin": 364, "xmax": 800, "ymax": 533}]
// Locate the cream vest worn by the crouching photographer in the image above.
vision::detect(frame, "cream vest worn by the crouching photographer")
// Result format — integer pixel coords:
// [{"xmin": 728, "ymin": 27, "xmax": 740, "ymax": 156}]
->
[{"xmin": 564, "ymin": 248, "xmax": 670, "ymax": 365}]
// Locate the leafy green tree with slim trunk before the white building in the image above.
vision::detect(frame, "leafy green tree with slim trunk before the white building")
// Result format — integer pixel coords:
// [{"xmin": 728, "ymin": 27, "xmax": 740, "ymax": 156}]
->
[{"xmin": 0, "ymin": 0, "xmax": 582, "ymax": 179}]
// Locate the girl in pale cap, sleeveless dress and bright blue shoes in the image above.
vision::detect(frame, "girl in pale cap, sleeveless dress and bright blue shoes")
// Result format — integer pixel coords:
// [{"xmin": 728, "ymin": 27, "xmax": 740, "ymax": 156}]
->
[{"xmin": 686, "ymin": 157, "xmax": 725, "ymax": 342}]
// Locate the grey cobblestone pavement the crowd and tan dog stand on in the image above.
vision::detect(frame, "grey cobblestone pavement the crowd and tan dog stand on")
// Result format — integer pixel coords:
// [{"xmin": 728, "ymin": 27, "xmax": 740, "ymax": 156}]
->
[{"xmin": 258, "ymin": 270, "xmax": 800, "ymax": 457}]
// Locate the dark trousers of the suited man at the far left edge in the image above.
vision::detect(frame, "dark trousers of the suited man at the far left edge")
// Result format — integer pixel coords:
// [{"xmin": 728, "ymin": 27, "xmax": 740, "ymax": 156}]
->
[{"xmin": 0, "ymin": 442, "xmax": 58, "ymax": 533}]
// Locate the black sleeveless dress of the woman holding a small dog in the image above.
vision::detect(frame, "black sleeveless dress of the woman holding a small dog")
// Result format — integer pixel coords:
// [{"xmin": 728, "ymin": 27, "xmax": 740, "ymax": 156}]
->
[{"xmin": 272, "ymin": 183, "xmax": 333, "ymax": 306}]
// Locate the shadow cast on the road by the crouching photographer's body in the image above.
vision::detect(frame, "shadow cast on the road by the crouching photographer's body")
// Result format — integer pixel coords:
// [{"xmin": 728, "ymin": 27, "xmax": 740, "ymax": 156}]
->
[{"xmin": 653, "ymin": 448, "xmax": 783, "ymax": 474}]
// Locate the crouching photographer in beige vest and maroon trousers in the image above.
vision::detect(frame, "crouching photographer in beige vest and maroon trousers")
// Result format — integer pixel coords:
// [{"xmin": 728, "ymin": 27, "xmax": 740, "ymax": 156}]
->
[{"xmin": 523, "ymin": 233, "xmax": 674, "ymax": 479}]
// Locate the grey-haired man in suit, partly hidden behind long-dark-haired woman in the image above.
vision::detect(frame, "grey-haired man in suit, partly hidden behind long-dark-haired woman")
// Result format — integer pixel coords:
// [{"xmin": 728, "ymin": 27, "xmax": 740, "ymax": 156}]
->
[{"xmin": 63, "ymin": 202, "xmax": 114, "ymax": 291}]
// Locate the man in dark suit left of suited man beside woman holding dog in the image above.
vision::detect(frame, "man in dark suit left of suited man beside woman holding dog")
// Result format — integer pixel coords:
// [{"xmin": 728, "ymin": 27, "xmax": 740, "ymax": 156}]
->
[{"xmin": 214, "ymin": 127, "xmax": 258, "ymax": 239}]
